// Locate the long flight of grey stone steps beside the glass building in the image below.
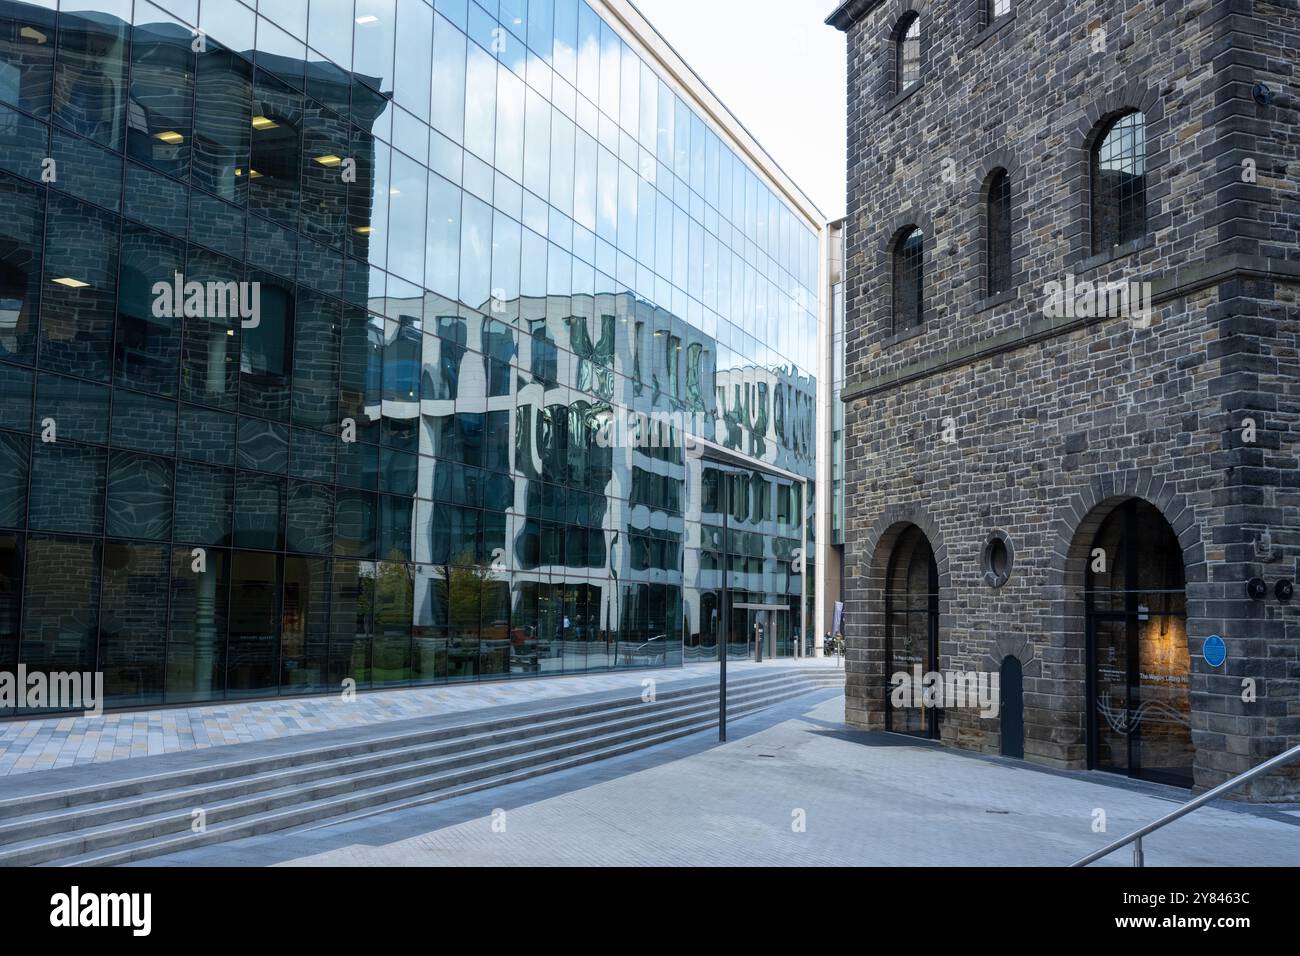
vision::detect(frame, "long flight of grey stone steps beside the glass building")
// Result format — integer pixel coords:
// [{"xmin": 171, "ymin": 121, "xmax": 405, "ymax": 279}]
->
[{"xmin": 0, "ymin": 667, "xmax": 844, "ymax": 866}]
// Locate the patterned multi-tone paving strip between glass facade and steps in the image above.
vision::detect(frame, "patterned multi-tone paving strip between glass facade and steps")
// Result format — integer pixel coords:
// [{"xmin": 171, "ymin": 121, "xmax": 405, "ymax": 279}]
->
[{"xmin": 0, "ymin": 661, "xmax": 835, "ymax": 777}]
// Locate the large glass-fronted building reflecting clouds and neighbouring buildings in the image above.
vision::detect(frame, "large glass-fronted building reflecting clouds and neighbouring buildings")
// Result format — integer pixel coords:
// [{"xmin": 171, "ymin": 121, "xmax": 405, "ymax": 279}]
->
[{"xmin": 0, "ymin": 0, "xmax": 819, "ymax": 706}]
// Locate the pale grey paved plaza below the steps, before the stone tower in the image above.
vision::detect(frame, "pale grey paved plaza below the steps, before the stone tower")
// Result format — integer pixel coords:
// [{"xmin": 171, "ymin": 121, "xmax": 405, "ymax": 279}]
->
[{"xmin": 137, "ymin": 689, "xmax": 1300, "ymax": 866}]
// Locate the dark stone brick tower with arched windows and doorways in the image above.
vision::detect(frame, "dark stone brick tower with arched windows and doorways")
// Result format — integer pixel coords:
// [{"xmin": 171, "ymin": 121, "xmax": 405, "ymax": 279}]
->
[{"xmin": 828, "ymin": 0, "xmax": 1300, "ymax": 800}]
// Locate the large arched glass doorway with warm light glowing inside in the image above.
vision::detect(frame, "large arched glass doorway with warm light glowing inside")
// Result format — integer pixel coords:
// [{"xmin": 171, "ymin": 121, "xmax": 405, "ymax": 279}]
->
[{"xmin": 1084, "ymin": 498, "xmax": 1195, "ymax": 787}]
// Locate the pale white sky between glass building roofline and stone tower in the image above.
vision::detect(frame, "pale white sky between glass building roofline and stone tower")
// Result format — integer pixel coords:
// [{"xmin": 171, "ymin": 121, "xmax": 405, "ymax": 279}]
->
[{"xmin": 633, "ymin": 0, "xmax": 846, "ymax": 220}]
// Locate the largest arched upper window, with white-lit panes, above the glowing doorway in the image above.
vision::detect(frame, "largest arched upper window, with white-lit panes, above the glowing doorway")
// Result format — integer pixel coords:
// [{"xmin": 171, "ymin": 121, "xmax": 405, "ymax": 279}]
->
[{"xmin": 1092, "ymin": 112, "xmax": 1147, "ymax": 254}]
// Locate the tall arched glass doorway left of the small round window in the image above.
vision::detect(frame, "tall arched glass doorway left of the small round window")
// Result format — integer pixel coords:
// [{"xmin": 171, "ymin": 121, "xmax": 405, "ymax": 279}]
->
[{"xmin": 885, "ymin": 525, "xmax": 939, "ymax": 739}]
